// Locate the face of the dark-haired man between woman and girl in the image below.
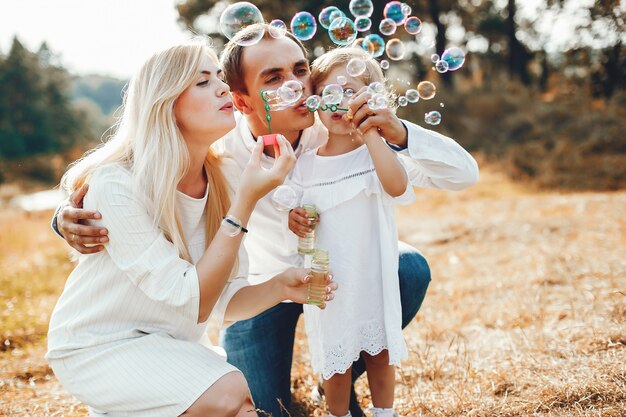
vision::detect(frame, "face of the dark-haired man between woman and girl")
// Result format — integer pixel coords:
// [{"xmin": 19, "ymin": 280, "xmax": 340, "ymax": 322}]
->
[{"xmin": 237, "ymin": 37, "xmax": 315, "ymax": 139}]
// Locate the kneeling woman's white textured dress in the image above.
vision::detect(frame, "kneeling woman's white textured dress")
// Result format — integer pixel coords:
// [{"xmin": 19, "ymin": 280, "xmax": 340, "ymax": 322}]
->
[{"xmin": 46, "ymin": 164, "xmax": 248, "ymax": 417}]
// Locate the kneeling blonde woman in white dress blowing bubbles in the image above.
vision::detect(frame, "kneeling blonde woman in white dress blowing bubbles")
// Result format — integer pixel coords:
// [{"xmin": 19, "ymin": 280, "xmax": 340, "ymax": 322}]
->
[{"xmin": 47, "ymin": 43, "xmax": 336, "ymax": 417}]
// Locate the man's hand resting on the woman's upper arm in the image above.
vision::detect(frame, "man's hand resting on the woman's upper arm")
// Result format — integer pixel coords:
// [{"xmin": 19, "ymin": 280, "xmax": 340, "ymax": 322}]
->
[{"xmin": 52, "ymin": 184, "xmax": 109, "ymax": 254}]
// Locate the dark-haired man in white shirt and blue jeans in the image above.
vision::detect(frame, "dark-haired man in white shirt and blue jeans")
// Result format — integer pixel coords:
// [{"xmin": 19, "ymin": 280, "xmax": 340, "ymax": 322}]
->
[{"xmin": 55, "ymin": 25, "xmax": 478, "ymax": 417}]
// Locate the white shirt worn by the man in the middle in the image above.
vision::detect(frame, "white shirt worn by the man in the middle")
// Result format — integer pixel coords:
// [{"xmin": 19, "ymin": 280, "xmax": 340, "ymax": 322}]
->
[{"xmin": 214, "ymin": 113, "xmax": 478, "ymax": 284}]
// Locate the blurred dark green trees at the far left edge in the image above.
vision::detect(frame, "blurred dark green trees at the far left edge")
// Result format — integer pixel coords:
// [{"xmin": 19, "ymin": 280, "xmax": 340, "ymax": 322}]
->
[{"xmin": 0, "ymin": 38, "xmax": 92, "ymax": 158}]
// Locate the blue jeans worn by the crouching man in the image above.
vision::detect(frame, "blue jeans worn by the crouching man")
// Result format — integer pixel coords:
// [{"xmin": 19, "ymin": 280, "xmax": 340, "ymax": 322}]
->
[{"xmin": 220, "ymin": 242, "xmax": 430, "ymax": 417}]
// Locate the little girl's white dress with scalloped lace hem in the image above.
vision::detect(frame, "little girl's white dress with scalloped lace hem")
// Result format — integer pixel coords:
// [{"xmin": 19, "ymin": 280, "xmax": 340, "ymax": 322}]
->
[{"xmin": 292, "ymin": 145, "xmax": 414, "ymax": 379}]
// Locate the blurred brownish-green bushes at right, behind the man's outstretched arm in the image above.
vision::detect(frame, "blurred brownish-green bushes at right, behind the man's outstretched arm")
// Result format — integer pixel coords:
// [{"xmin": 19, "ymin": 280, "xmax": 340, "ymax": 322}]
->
[{"xmin": 400, "ymin": 85, "xmax": 626, "ymax": 190}]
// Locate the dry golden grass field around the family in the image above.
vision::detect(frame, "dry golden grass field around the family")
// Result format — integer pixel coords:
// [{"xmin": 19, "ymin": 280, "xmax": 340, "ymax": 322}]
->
[{"xmin": 0, "ymin": 167, "xmax": 626, "ymax": 417}]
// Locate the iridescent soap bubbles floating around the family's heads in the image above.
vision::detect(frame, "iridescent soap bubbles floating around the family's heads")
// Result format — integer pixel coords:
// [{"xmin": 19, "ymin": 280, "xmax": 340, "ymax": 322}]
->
[{"xmin": 220, "ymin": 0, "xmax": 465, "ymax": 130}]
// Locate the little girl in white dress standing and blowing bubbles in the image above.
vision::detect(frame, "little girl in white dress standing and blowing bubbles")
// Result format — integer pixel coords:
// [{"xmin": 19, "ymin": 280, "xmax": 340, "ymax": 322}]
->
[{"xmin": 290, "ymin": 48, "xmax": 414, "ymax": 417}]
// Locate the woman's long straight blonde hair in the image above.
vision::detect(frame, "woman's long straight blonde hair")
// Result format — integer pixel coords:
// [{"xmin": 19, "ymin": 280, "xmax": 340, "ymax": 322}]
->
[{"xmin": 61, "ymin": 41, "xmax": 230, "ymax": 262}]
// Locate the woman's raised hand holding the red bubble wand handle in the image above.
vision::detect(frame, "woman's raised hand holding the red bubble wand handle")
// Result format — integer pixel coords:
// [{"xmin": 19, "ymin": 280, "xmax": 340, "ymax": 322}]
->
[{"xmin": 238, "ymin": 135, "xmax": 296, "ymax": 202}]
